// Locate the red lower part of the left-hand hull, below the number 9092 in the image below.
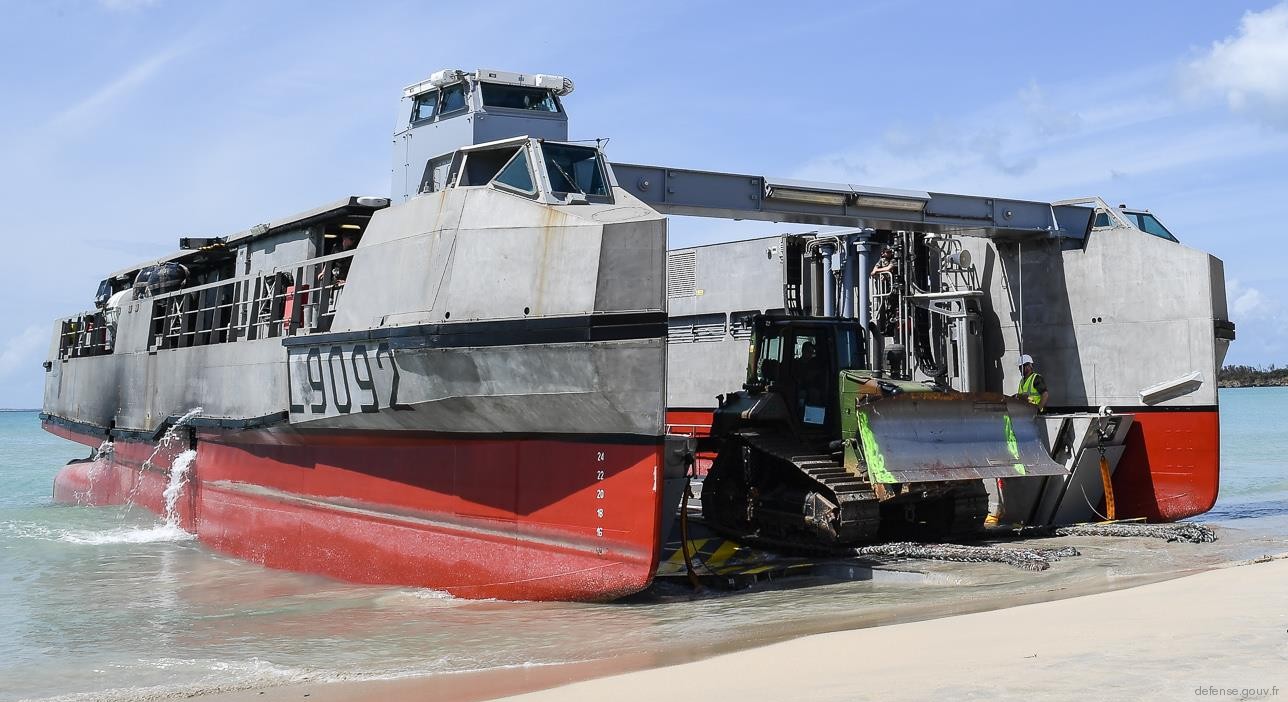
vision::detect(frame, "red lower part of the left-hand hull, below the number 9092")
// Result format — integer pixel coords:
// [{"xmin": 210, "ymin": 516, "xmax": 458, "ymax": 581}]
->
[{"xmin": 45, "ymin": 422, "xmax": 663, "ymax": 600}]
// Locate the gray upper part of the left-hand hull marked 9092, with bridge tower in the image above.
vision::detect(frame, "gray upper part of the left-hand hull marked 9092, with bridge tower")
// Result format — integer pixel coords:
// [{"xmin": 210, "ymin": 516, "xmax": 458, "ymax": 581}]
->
[{"xmin": 45, "ymin": 71, "xmax": 666, "ymax": 437}]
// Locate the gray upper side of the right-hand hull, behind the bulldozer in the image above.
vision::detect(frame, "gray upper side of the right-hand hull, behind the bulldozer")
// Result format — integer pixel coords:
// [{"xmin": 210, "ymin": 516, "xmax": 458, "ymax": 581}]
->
[{"xmin": 667, "ymin": 198, "xmax": 1234, "ymax": 408}]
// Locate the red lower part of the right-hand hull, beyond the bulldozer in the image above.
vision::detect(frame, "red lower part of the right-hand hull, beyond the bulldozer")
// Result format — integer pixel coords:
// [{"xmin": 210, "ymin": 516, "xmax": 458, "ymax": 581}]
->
[{"xmin": 666, "ymin": 407, "xmax": 1221, "ymax": 522}]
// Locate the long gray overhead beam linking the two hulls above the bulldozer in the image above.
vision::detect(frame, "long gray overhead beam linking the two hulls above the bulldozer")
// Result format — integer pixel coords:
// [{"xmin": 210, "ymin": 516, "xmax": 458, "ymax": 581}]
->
[{"xmin": 612, "ymin": 164, "xmax": 1071, "ymax": 238}]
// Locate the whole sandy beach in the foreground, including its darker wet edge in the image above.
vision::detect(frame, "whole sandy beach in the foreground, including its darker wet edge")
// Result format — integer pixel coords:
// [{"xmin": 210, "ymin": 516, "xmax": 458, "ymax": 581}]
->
[{"xmin": 218, "ymin": 546, "xmax": 1288, "ymax": 702}]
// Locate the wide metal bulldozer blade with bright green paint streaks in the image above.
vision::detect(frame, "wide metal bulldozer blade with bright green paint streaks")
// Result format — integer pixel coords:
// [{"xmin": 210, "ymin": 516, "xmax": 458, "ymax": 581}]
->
[{"xmin": 857, "ymin": 393, "xmax": 1068, "ymax": 483}]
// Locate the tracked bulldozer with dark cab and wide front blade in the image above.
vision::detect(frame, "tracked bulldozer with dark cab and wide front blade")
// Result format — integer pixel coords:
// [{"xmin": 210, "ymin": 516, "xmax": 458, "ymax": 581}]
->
[{"xmin": 702, "ymin": 314, "xmax": 1065, "ymax": 551}]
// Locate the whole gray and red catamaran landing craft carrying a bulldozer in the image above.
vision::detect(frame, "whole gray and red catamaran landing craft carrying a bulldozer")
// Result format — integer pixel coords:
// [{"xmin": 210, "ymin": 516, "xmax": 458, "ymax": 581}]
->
[{"xmin": 41, "ymin": 71, "xmax": 1234, "ymax": 600}]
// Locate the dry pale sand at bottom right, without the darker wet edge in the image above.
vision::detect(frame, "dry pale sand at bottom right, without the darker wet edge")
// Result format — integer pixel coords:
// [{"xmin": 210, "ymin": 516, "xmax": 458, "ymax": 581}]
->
[{"xmin": 492, "ymin": 559, "xmax": 1288, "ymax": 702}]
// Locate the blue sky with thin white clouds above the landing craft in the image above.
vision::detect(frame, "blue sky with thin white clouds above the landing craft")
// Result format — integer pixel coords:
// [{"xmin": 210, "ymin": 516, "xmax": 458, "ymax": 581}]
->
[{"xmin": 0, "ymin": 0, "xmax": 1288, "ymax": 407}]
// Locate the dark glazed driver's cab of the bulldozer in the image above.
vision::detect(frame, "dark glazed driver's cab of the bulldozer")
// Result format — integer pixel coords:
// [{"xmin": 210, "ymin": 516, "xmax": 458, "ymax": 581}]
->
[{"xmin": 746, "ymin": 316, "xmax": 867, "ymax": 437}]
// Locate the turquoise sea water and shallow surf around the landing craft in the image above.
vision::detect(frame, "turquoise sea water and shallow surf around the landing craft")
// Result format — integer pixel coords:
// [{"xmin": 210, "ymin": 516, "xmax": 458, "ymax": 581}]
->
[{"xmin": 0, "ymin": 388, "xmax": 1288, "ymax": 701}]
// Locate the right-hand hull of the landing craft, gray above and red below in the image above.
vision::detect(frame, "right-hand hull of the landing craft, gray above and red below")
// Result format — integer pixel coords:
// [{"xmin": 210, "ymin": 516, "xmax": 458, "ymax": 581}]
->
[{"xmin": 664, "ymin": 189, "xmax": 1234, "ymax": 524}]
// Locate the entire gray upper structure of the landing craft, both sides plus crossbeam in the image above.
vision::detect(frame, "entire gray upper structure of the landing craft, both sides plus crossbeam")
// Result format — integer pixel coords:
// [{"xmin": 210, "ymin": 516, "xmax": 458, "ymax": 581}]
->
[{"xmin": 44, "ymin": 71, "xmax": 1234, "ymax": 535}]
